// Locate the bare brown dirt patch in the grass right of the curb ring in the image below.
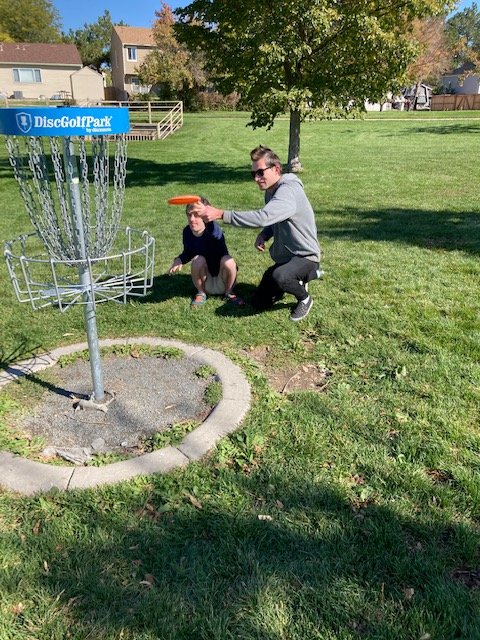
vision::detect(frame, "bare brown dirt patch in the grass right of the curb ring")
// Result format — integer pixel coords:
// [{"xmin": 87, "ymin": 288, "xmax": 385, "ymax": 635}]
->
[{"xmin": 244, "ymin": 346, "xmax": 332, "ymax": 393}]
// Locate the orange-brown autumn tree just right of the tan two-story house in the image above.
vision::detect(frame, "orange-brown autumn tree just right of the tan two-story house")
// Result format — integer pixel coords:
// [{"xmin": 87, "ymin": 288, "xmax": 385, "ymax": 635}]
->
[{"xmin": 137, "ymin": 2, "xmax": 205, "ymax": 99}]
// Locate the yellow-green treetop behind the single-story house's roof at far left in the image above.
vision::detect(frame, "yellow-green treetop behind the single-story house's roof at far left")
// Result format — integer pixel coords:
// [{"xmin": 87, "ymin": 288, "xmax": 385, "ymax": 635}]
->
[{"xmin": 0, "ymin": 0, "xmax": 61, "ymax": 43}]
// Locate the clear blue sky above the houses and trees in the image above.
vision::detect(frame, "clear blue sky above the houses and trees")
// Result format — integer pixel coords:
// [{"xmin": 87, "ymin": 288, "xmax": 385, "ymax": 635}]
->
[{"xmin": 52, "ymin": 0, "xmax": 478, "ymax": 32}]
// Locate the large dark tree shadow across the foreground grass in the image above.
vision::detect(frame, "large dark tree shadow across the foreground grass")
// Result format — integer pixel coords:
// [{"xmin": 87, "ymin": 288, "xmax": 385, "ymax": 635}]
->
[{"xmin": 26, "ymin": 468, "xmax": 478, "ymax": 640}]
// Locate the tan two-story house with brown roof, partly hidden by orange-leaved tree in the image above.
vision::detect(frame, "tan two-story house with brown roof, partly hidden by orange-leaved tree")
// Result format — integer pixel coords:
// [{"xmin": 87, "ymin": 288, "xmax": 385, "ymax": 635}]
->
[{"xmin": 111, "ymin": 25, "xmax": 157, "ymax": 100}]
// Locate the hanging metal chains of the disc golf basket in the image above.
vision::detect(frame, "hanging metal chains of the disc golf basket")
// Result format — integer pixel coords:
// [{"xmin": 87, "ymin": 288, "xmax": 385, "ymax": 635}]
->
[{"xmin": 6, "ymin": 135, "xmax": 127, "ymax": 262}]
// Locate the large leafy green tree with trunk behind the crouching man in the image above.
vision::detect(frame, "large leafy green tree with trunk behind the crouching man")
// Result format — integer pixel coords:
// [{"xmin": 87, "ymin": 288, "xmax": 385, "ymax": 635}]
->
[{"xmin": 175, "ymin": 0, "xmax": 453, "ymax": 170}]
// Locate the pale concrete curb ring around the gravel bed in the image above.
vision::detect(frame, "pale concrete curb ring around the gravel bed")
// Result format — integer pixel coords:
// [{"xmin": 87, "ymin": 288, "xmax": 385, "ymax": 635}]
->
[{"xmin": 0, "ymin": 337, "xmax": 251, "ymax": 495}]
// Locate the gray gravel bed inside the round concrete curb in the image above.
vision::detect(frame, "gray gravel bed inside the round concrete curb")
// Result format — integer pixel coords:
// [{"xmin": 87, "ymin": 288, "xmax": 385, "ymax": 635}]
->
[{"xmin": 12, "ymin": 356, "xmax": 210, "ymax": 453}]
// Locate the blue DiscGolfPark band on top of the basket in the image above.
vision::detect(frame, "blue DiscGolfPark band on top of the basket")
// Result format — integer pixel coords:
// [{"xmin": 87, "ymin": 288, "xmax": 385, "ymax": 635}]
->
[{"xmin": 0, "ymin": 107, "xmax": 130, "ymax": 137}]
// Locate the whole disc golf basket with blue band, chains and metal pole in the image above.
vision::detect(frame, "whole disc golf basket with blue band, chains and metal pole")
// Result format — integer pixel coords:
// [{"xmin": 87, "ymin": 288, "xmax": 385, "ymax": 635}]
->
[{"xmin": 0, "ymin": 107, "xmax": 155, "ymax": 407}]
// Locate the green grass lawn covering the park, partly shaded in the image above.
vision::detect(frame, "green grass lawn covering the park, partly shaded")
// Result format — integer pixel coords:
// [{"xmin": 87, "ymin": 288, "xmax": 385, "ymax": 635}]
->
[{"xmin": 0, "ymin": 112, "xmax": 480, "ymax": 640}]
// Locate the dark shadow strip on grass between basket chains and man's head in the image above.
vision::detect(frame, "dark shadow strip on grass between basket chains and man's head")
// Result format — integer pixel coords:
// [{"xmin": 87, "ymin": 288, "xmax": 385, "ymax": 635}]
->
[{"xmin": 126, "ymin": 156, "xmax": 250, "ymax": 189}]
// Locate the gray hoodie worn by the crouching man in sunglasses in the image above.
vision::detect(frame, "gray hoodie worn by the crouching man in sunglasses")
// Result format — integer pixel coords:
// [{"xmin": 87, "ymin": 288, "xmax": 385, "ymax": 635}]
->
[{"xmin": 223, "ymin": 173, "xmax": 320, "ymax": 263}]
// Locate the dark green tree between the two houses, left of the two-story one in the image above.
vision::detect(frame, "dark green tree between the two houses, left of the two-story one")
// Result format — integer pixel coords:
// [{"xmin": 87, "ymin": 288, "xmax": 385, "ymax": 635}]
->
[{"xmin": 63, "ymin": 10, "xmax": 126, "ymax": 71}]
